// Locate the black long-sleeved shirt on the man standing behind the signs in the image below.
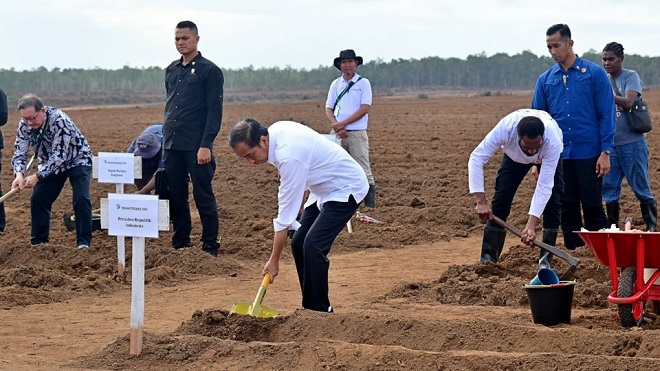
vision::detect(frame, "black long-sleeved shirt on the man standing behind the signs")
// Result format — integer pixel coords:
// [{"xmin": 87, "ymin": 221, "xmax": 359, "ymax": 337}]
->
[{"xmin": 163, "ymin": 53, "xmax": 224, "ymax": 152}]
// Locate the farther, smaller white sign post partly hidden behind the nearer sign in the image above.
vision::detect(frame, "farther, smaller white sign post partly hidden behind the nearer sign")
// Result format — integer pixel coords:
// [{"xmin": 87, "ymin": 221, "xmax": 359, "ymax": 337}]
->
[{"xmin": 92, "ymin": 152, "xmax": 142, "ymax": 277}]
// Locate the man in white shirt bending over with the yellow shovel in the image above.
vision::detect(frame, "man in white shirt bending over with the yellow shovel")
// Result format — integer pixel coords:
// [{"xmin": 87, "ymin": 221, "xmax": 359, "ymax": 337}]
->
[{"xmin": 229, "ymin": 118, "xmax": 369, "ymax": 312}]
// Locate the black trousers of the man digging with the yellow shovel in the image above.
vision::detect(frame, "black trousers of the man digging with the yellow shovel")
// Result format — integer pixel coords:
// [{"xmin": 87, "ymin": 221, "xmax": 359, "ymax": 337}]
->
[{"xmin": 291, "ymin": 195, "xmax": 359, "ymax": 312}]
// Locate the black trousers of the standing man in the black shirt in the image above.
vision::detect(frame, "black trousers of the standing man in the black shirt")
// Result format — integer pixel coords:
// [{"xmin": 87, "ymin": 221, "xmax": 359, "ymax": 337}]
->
[{"xmin": 163, "ymin": 150, "xmax": 220, "ymax": 248}]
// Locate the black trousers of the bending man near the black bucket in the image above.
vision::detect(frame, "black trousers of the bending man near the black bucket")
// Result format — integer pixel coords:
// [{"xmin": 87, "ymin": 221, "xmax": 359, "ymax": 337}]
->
[{"xmin": 487, "ymin": 154, "xmax": 564, "ymax": 229}]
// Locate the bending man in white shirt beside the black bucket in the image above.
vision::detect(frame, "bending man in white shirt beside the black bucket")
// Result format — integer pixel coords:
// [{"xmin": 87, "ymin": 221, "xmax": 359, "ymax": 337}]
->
[{"xmin": 468, "ymin": 109, "xmax": 564, "ymax": 268}]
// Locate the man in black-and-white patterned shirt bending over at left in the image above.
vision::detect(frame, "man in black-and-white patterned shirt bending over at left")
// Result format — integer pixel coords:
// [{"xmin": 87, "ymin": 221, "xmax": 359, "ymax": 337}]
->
[{"xmin": 11, "ymin": 94, "xmax": 92, "ymax": 249}]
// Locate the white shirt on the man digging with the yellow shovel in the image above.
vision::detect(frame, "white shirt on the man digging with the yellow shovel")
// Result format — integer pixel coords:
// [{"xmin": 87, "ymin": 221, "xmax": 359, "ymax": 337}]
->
[{"xmin": 268, "ymin": 121, "xmax": 369, "ymax": 232}]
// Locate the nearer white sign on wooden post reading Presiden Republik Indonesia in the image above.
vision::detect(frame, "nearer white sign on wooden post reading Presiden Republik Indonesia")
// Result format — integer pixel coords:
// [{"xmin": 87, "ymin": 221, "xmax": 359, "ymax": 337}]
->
[{"xmin": 101, "ymin": 193, "xmax": 170, "ymax": 355}]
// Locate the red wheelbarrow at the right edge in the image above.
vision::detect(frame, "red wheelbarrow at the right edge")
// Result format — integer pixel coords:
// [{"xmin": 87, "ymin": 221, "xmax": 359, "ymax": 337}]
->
[{"xmin": 575, "ymin": 231, "xmax": 660, "ymax": 327}]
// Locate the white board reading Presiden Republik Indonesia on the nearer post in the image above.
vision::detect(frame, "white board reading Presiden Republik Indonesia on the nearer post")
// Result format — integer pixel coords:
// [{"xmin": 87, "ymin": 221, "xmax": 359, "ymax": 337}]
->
[{"xmin": 108, "ymin": 193, "xmax": 158, "ymax": 238}]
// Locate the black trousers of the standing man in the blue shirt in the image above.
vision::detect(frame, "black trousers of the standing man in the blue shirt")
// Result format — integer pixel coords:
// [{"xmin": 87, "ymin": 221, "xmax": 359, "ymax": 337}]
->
[{"xmin": 561, "ymin": 157, "xmax": 607, "ymax": 250}]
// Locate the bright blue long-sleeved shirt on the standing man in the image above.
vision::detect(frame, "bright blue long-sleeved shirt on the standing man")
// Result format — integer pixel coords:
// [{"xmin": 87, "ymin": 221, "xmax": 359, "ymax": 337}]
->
[{"xmin": 532, "ymin": 57, "xmax": 616, "ymax": 159}]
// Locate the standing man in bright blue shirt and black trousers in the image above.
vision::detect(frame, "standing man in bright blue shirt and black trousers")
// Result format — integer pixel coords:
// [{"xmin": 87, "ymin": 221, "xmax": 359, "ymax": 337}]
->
[{"xmin": 532, "ymin": 24, "xmax": 616, "ymax": 250}]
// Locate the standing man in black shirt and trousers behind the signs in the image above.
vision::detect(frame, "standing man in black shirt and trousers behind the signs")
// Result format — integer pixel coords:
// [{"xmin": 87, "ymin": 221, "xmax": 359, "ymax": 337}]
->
[{"xmin": 163, "ymin": 21, "xmax": 224, "ymax": 256}]
